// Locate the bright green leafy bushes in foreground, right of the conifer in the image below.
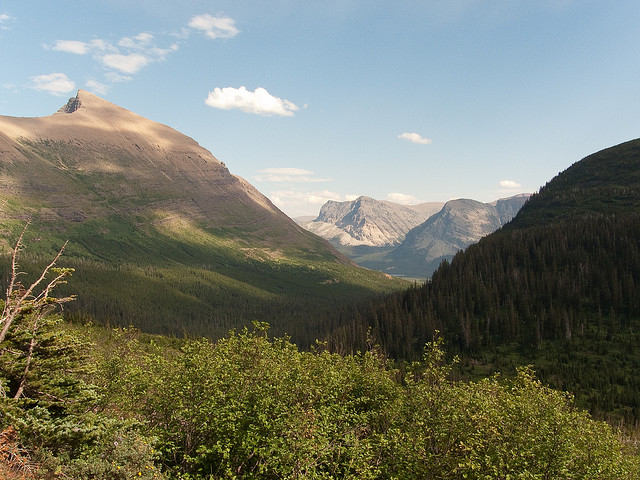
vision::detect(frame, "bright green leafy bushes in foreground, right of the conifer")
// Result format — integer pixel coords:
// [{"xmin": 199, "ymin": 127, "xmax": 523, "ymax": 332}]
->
[{"xmin": 91, "ymin": 325, "xmax": 639, "ymax": 479}]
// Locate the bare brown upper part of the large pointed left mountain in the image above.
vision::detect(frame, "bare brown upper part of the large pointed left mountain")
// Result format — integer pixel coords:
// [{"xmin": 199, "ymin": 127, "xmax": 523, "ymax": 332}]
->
[{"xmin": 0, "ymin": 90, "xmax": 292, "ymax": 237}]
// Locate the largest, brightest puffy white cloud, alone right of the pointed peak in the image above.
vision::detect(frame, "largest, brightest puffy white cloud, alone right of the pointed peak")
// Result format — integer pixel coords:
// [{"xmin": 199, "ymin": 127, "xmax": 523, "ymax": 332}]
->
[{"xmin": 204, "ymin": 86, "xmax": 298, "ymax": 117}]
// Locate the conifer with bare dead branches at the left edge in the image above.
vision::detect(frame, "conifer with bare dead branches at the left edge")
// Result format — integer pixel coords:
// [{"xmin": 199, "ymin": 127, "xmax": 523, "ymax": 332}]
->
[{"xmin": 0, "ymin": 236, "xmax": 164, "ymax": 479}]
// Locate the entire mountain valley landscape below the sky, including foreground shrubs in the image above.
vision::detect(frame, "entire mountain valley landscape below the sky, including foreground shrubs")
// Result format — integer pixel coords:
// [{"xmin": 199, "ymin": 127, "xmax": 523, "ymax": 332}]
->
[{"xmin": 0, "ymin": 90, "xmax": 640, "ymax": 480}]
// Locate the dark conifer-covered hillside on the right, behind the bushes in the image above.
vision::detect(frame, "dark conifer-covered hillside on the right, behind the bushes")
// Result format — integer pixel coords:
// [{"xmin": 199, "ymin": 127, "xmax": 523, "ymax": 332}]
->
[{"xmin": 332, "ymin": 140, "xmax": 640, "ymax": 423}]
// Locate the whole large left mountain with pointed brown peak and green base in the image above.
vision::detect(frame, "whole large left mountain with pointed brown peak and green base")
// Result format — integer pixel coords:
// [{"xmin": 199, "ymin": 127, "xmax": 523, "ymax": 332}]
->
[{"xmin": 0, "ymin": 90, "xmax": 398, "ymax": 343}]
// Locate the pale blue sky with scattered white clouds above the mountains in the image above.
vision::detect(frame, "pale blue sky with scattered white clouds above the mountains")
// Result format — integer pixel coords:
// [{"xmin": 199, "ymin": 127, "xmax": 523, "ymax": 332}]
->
[{"xmin": 0, "ymin": 0, "xmax": 640, "ymax": 217}]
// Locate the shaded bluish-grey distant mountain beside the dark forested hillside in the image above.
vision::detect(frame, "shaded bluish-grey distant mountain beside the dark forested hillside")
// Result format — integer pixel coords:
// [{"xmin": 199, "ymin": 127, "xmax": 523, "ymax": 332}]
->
[{"xmin": 389, "ymin": 194, "xmax": 529, "ymax": 278}]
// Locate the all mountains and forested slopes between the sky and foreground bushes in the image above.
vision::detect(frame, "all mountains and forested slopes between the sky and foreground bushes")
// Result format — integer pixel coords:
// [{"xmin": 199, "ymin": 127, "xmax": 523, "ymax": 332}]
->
[{"xmin": 5, "ymin": 90, "xmax": 640, "ymax": 426}]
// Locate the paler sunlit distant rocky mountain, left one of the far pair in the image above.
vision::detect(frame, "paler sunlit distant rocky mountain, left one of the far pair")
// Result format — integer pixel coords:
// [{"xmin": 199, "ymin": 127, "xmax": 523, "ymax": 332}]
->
[{"xmin": 302, "ymin": 196, "xmax": 442, "ymax": 247}]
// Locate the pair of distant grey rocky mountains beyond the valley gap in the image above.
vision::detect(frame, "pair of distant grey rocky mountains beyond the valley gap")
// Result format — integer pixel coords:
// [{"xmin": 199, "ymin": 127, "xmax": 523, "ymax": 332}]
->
[{"xmin": 301, "ymin": 194, "xmax": 529, "ymax": 278}]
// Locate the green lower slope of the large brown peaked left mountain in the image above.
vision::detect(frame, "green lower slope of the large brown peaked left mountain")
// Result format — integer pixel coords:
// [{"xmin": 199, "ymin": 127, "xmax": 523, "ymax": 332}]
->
[{"xmin": 0, "ymin": 216, "xmax": 408, "ymax": 345}]
